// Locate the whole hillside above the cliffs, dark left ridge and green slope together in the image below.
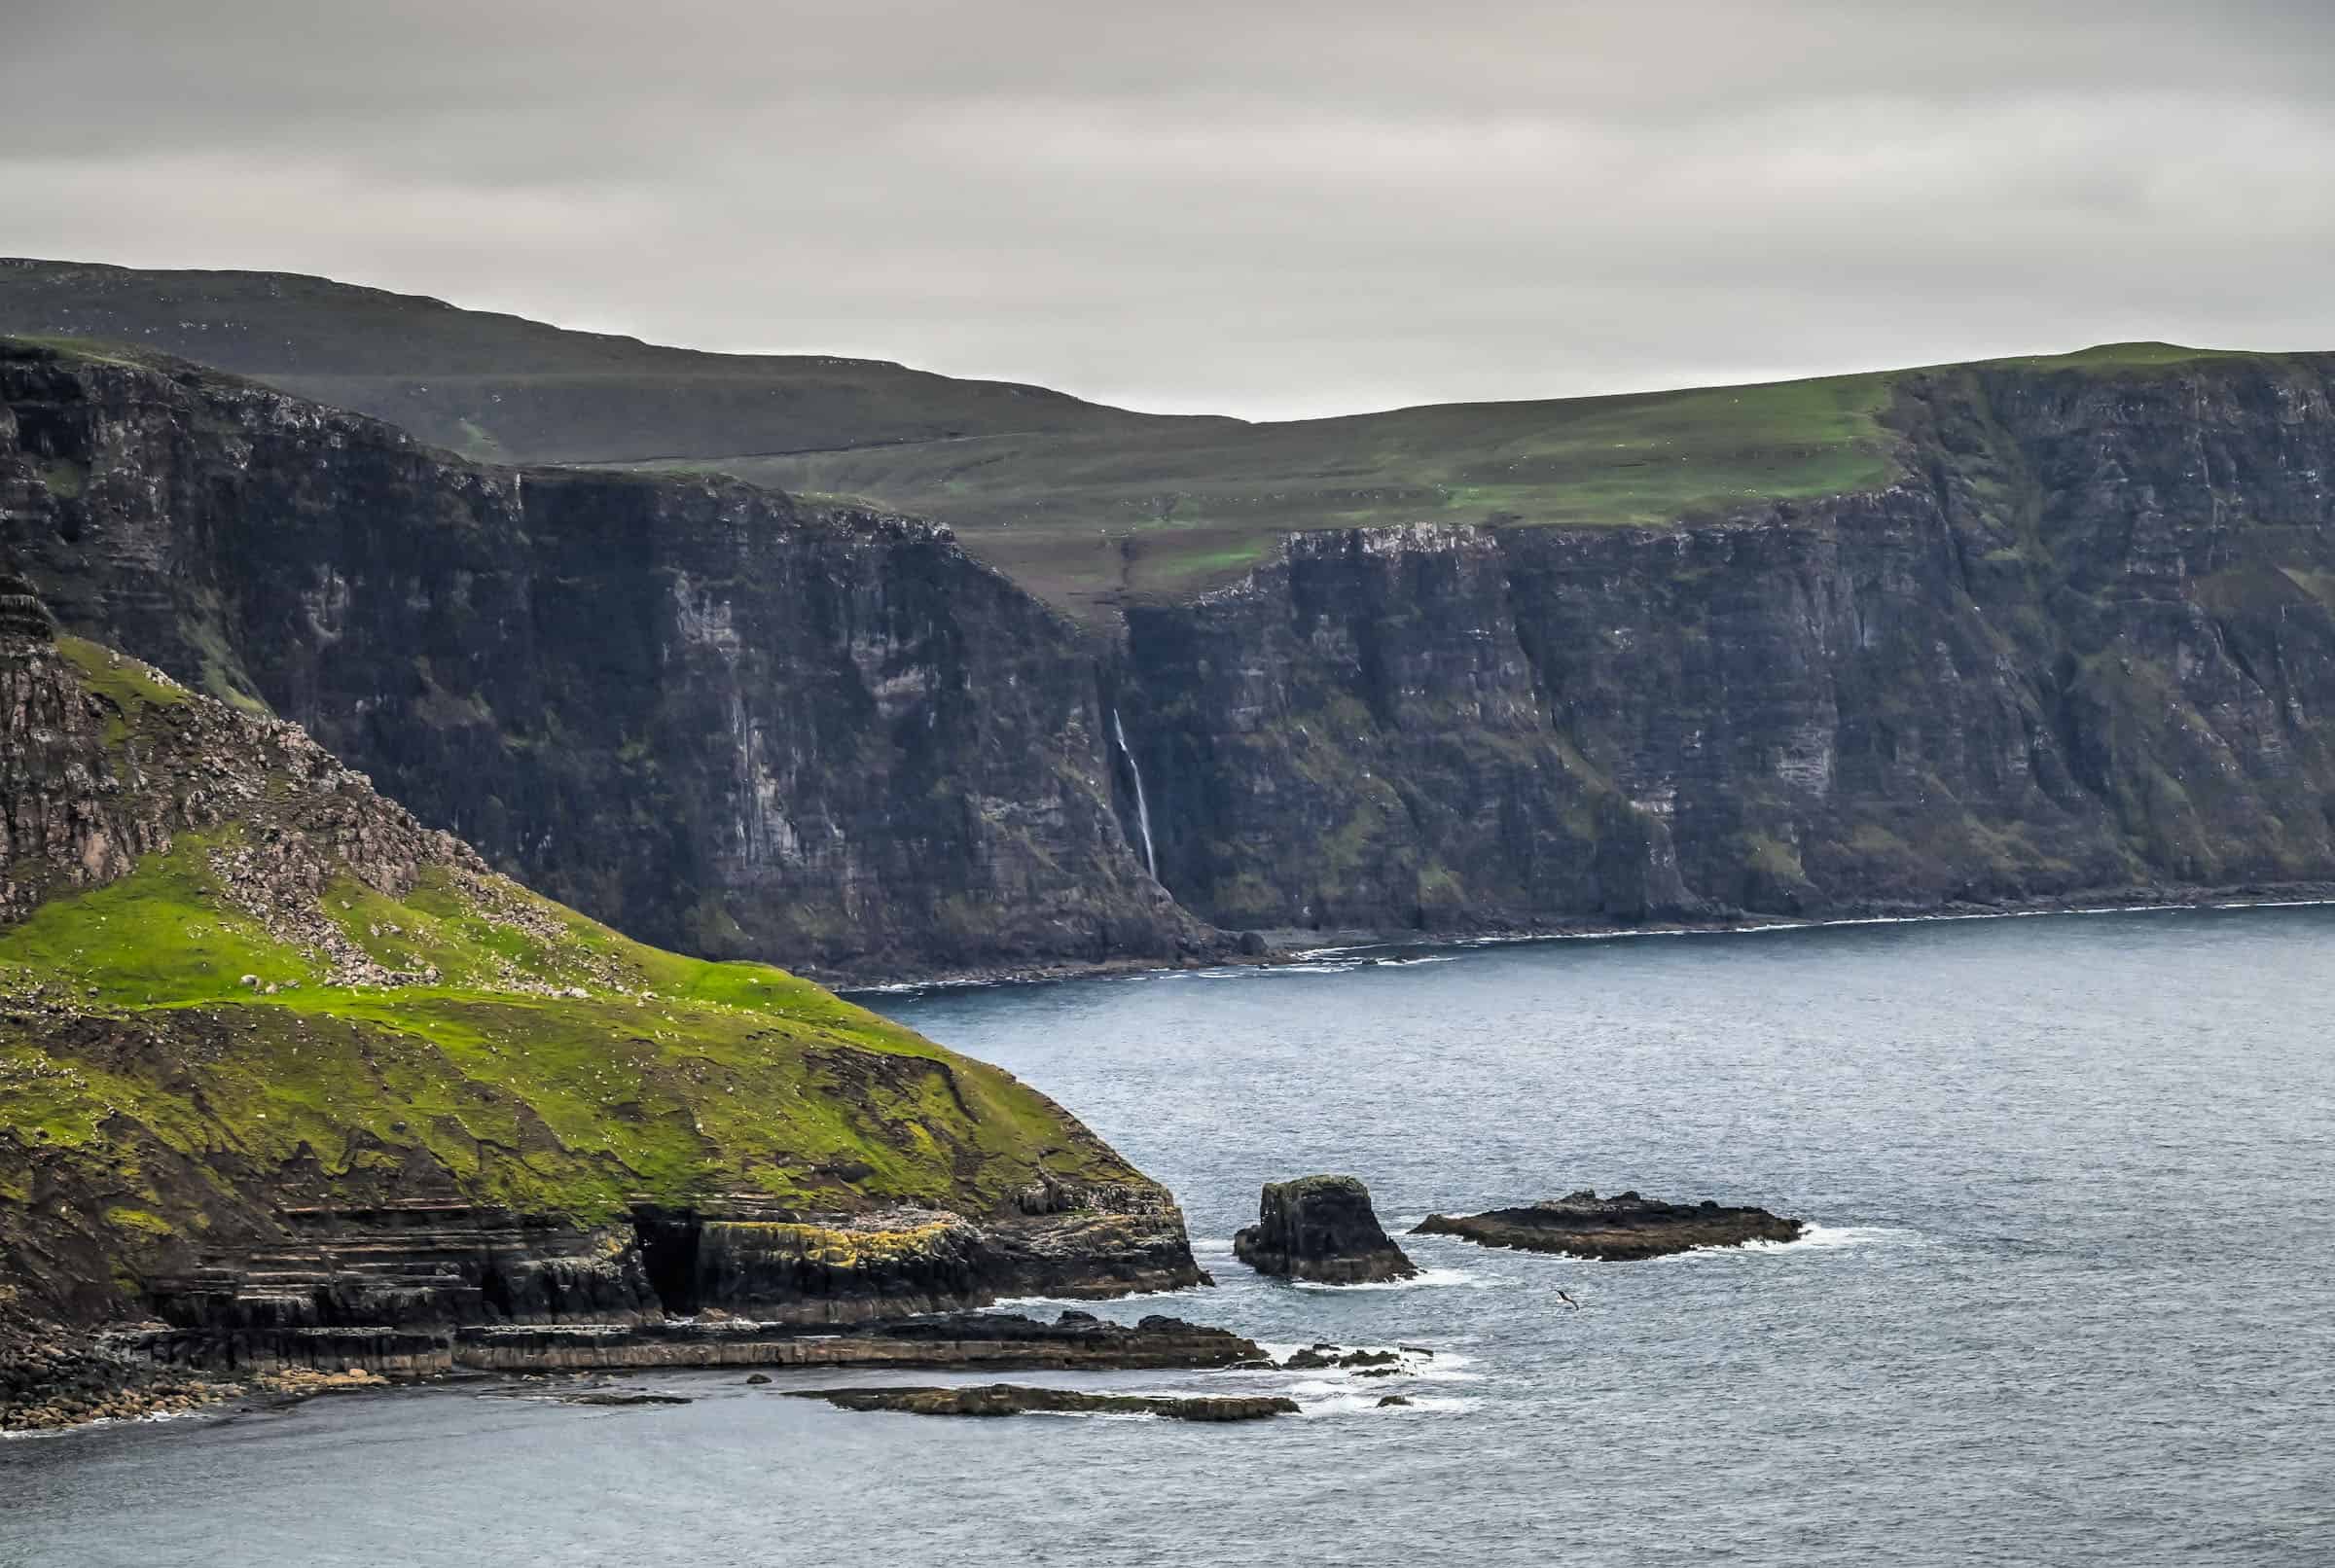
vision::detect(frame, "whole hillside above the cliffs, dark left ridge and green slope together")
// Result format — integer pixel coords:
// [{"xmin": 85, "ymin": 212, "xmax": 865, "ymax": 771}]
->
[{"xmin": 0, "ymin": 262, "xmax": 2305, "ymax": 623}]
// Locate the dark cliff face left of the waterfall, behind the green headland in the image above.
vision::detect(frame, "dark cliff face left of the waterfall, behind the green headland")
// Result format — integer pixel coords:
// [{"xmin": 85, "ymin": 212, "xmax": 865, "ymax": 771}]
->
[{"xmin": 0, "ymin": 350, "xmax": 1207, "ymax": 976}]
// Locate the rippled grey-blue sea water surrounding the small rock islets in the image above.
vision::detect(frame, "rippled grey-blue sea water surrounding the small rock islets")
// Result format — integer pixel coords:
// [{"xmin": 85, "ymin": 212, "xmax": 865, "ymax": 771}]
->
[{"xmin": 0, "ymin": 910, "xmax": 2335, "ymax": 1568}]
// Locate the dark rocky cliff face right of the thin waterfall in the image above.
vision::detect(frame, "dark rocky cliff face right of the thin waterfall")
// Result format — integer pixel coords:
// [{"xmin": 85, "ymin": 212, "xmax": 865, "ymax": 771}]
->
[{"xmin": 1123, "ymin": 359, "xmax": 2335, "ymax": 929}]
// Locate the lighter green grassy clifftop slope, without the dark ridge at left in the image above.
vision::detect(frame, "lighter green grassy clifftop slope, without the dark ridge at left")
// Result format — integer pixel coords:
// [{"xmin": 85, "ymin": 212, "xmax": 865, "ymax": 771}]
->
[{"xmin": 696, "ymin": 343, "xmax": 2316, "ymax": 616}]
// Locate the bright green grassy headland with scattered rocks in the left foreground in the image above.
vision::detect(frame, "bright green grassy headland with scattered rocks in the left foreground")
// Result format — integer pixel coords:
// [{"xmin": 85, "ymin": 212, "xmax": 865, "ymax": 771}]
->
[{"xmin": 0, "ymin": 611, "xmax": 1181, "ymax": 1321}]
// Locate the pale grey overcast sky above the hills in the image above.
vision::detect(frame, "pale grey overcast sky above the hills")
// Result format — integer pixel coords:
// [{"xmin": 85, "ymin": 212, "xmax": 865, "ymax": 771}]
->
[{"xmin": 0, "ymin": 0, "xmax": 2335, "ymax": 417}]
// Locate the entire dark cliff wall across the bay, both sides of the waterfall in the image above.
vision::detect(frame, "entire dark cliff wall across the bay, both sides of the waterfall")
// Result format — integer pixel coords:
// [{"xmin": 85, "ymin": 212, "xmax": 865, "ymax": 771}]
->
[{"xmin": 0, "ymin": 338, "xmax": 2335, "ymax": 978}]
